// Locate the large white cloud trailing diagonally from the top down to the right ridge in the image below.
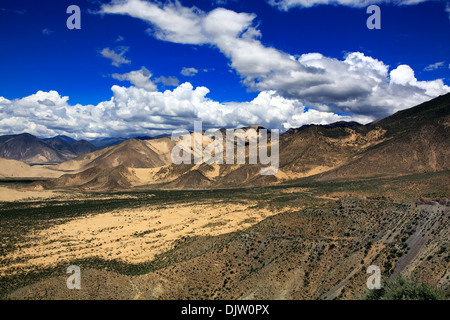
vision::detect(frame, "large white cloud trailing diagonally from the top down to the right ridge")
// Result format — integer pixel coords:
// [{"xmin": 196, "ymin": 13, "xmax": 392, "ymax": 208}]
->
[{"xmin": 101, "ymin": 0, "xmax": 450, "ymax": 117}]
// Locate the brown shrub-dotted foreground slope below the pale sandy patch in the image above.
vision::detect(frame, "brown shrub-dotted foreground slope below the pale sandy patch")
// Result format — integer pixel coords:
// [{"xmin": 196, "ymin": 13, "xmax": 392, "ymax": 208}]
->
[{"xmin": 5, "ymin": 199, "xmax": 450, "ymax": 299}]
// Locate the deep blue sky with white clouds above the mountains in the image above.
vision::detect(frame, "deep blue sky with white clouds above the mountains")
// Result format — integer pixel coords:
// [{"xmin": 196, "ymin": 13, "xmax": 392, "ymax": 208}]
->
[{"xmin": 0, "ymin": 0, "xmax": 450, "ymax": 138}]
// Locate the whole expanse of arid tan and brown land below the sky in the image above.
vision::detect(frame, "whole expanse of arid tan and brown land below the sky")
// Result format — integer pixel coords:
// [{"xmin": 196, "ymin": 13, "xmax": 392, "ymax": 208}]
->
[{"xmin": 0, "ymin": 95, "xmax": 450, "ymax": 299}]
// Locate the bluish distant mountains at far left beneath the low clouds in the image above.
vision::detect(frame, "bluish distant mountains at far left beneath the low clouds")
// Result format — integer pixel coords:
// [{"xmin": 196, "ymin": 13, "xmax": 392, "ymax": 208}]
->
[{"xmin": 0, "ymin": 133, "xmax": 97, "ymax": 164}]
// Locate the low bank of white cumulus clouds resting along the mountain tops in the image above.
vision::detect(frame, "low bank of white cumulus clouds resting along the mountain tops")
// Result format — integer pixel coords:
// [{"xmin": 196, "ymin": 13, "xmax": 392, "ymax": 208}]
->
[{"xmin": 0, "ymin": 82, "xmax": 373, "ymax": 139}]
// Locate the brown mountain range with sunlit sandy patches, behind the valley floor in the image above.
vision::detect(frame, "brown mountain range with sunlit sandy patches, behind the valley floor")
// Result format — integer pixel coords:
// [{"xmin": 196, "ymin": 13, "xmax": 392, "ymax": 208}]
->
[{"xmin": 33, "ymin": 94, "xmax": 450, "ymax": 189}]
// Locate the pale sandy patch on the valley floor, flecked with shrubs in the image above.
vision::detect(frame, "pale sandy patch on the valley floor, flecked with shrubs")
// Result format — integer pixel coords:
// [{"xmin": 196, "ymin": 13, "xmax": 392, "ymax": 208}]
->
[{"xmin": 0, "ymin": 202, "xmax": 274, "ymax": 275}]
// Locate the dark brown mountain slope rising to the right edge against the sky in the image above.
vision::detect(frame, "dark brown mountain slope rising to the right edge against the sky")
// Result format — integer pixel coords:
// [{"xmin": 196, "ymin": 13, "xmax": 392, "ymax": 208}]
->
[{"xmin": 319, "ymin": 94, "xmax": 450, "ymax": 179}]
